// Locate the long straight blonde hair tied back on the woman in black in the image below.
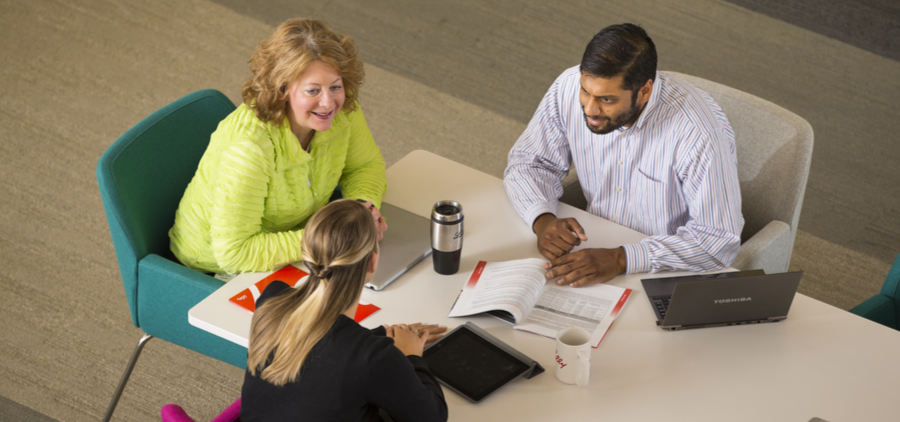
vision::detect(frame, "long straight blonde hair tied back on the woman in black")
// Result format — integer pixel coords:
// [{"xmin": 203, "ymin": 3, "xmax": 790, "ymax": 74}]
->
[{"xmin": 247, "ymin": 200, "xmax": 378, "ymax": 386}]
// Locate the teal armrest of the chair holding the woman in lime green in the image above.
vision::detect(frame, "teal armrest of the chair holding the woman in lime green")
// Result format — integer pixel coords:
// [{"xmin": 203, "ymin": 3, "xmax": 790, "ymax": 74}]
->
[{"xmin": 137, "ymin": 254, "xmax": 247, "ymax": 368}]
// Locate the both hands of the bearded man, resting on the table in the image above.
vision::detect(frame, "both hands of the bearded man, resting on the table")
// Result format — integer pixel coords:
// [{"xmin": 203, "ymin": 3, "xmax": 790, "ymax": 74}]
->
[{"xmin": 532, "ymin": 214, "xmax": 628, "ymax": 287}]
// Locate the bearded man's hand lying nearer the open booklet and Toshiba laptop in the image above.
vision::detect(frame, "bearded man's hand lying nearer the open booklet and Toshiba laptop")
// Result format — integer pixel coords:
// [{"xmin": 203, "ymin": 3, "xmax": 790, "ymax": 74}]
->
[{"xmin": 544, "ymin": 247, "xmax": 628, "ymax": 287}]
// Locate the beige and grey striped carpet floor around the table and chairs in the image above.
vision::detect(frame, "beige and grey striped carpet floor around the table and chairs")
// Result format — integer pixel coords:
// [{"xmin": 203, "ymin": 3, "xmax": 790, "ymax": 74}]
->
[{"xmin": 0, "ymin": 0, "xmax": 900, "ymax": 421}]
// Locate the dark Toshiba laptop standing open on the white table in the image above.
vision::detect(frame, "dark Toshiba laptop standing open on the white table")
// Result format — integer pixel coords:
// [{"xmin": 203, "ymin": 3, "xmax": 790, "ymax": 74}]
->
[{"xmin": 641, "ymin": 270, "xmax": 803, "ymax": 331}]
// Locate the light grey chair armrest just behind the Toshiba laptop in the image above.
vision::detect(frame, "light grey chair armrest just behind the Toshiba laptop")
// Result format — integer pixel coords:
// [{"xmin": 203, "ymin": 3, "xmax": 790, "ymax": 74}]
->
[{"xmin": 731, "ymin": 220, "xmax": 794, "ymax": 274}]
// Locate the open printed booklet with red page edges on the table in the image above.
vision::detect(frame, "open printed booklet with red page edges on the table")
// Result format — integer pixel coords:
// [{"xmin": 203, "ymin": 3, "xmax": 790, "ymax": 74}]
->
[{"xmin": 448, "ymin": 258, "xmax": 631, "ymax": 348}]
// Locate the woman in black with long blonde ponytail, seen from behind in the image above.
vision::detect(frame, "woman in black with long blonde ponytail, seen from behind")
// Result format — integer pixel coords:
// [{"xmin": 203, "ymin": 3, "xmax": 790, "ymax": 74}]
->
[{"xmin": 241, "ymin": 200, "xmax": 447, "ymax": 422}]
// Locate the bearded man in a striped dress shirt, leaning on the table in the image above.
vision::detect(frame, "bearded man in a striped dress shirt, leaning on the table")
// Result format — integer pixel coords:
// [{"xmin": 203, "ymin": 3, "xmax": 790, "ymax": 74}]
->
[{"xmin": 503, "ymin": 24, "xmax": 744, "ymax": 287}]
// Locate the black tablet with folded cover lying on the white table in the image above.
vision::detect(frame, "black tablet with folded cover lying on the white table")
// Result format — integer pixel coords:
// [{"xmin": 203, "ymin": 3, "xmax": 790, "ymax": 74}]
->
[{"xmin": 422, "ymin": 322, "xmax": 544, "ymax": 403}]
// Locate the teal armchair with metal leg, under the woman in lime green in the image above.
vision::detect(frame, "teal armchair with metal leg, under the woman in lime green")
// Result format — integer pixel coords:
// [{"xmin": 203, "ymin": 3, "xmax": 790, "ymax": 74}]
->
[{"xmin": 97, "ymin": 90, "xmax": 247, "ymax": 421}]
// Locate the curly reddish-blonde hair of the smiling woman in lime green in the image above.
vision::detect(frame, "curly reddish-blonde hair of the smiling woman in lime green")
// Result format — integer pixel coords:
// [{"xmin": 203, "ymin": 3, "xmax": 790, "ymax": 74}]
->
[{"xmin": 241, "ymin": 18, "xmax": 365, "ymax": 124}]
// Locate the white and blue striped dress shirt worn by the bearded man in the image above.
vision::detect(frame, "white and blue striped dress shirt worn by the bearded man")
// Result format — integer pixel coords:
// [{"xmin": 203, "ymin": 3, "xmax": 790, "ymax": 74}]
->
[{"xmin": 503, "ymin": 66, "xmax": 744, "ymax": 273}]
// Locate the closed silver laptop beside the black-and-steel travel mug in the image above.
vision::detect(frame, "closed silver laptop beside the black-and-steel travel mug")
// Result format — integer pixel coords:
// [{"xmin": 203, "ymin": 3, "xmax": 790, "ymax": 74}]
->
[{"xmin": 366, "ymin": 202, "xmax": 431, "ymax": 290}]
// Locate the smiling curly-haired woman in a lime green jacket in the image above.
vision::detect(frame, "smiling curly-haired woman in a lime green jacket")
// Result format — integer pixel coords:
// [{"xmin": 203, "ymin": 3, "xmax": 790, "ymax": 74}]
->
[{"xmin": 169, "ymin": 19, "xmax": 387, "ymax": 274}]
